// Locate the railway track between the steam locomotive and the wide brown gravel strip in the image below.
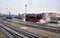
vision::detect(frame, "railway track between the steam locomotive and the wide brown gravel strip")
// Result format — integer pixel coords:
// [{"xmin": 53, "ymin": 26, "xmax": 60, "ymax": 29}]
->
[{"xmin": 3, "ymin": 21, "xmax": 60, "ymax": 33}]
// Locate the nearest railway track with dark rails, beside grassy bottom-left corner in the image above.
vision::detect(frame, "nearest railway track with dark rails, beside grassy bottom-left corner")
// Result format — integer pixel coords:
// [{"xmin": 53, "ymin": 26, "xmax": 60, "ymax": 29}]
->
[{"xmin": 0, "ymin": 25, "xmax": 22, "ymax": 38}]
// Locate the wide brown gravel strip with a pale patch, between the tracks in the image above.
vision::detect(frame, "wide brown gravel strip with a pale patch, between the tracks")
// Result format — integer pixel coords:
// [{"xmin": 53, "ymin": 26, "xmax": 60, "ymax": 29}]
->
[{"xmin": 7, "ymin": 22, "xmax": 60, "ymax": 38}]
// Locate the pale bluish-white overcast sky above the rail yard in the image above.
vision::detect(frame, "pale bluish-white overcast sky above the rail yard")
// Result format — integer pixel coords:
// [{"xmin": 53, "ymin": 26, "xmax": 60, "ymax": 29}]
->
[{"xmin": 0, "ymin": 0, "xmax": 60, "ymax": 14}]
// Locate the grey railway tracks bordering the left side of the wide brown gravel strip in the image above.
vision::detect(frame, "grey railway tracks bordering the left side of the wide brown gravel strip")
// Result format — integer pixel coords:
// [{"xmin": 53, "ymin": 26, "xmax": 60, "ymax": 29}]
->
[{"xmin": 0, "ymin": 21, "xmax": 46, "ymax": 38}]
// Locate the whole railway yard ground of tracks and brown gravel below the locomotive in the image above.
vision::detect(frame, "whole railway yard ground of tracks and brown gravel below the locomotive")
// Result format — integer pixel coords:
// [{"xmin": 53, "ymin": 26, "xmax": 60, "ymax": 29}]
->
[{"xmin": 0, "ymin": 19, "xmax": 60, "ymax": 38}]
